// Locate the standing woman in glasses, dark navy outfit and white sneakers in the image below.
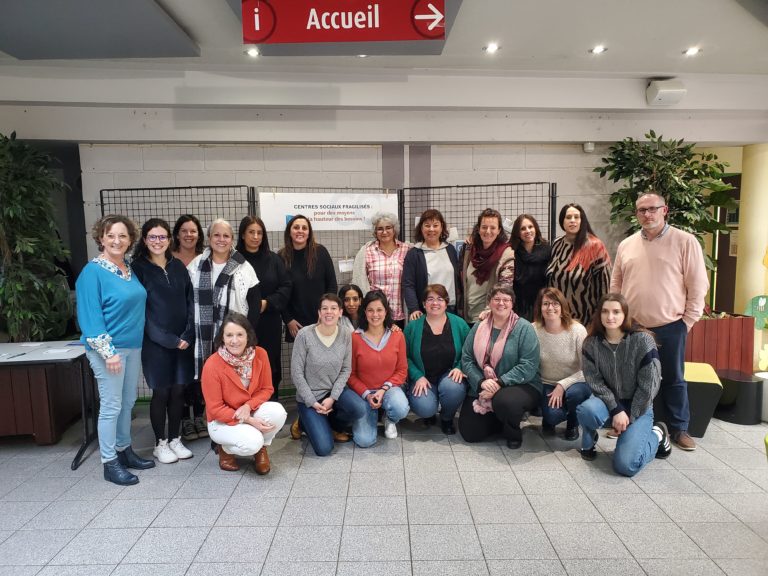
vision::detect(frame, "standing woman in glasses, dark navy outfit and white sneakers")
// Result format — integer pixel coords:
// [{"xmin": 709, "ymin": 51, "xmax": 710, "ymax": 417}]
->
[{"xmin": 132, "ymin": 218, "xmax": 195, "ymax": 464}]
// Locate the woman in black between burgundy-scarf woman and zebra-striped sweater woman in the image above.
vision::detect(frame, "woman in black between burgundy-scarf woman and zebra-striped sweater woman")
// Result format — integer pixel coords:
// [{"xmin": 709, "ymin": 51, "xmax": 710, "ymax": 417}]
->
[{"xmin": 509, "ymin": 214, "xmax": 552, "ymax": 322}]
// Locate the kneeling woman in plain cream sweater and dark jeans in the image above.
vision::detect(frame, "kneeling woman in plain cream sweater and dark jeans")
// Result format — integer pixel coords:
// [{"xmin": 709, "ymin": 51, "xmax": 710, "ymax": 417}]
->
[{"xmin": 533, "ymin": 288, "xmax": 592, "ymax": 441}]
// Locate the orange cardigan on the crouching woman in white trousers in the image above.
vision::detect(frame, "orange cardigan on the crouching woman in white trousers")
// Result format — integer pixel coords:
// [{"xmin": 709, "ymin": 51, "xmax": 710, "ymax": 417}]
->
[{"xmin": 202, "ymin": 346, "xmax": 274, "ymax": 426}]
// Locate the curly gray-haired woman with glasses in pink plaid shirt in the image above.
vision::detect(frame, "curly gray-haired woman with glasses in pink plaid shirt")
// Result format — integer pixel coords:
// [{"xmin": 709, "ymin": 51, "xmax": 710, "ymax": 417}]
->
[{"xmin": 352, "ymin": 212, "xmax": 411, "ymax": 328}]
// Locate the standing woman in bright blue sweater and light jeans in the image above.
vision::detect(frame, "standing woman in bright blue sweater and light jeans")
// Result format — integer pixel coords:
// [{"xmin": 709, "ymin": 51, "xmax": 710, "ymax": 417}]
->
[{"xmin": 75, "ymin": 214, "xmax": 155, "ymax": 486}]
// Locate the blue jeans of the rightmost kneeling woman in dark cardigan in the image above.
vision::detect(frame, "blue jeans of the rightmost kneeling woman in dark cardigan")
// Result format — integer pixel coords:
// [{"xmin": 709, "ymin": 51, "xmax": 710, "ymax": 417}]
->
[{"xmin": 576, "ymin": 396, "xmax": 659, "ymax": 477}]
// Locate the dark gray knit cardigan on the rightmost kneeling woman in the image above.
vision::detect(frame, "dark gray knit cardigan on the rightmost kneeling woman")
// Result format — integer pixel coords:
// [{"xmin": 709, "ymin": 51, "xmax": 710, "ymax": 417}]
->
[{"xmin": 582, "ymin": 332, "xmax": 661, "ymax": 422}]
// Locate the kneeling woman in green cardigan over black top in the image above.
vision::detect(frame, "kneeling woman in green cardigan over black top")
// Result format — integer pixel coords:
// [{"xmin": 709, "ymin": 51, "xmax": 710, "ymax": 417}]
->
[{"xmin": 405, "ymin": 284, "xmax": 469, "ymax": 434}]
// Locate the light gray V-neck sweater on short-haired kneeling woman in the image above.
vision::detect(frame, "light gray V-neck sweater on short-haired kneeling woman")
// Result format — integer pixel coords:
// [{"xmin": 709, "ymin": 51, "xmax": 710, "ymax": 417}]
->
[{"xmin": 291, "ymin": 324, "xmax": 352, "ymax": 407}]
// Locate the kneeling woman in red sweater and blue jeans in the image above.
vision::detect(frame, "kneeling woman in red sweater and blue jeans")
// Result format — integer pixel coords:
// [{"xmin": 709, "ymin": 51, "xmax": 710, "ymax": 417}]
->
[{"xmin": 338, "ymin": 290, "xmax": 409, "ymax": 448}]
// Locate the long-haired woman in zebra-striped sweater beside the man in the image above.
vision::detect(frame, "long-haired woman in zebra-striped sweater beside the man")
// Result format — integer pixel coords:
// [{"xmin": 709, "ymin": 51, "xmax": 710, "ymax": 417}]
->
[{"xmin": 547, "ymin": 203, "xmax": 611, "ymax": 325}]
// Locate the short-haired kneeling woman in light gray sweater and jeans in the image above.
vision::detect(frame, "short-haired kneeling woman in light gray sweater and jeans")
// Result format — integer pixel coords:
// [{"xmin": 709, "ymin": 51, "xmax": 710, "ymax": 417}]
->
[{"xmin": 291, "ymin": 294, "xmax": 366, "ymax": 456}]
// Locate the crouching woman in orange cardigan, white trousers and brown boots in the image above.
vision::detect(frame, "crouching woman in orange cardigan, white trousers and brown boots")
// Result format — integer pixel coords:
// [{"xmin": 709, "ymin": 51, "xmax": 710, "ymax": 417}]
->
[{"xmin": 202, "ymin": 312, "xmax": 287, "ymax": 474}]
